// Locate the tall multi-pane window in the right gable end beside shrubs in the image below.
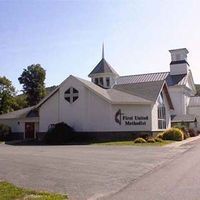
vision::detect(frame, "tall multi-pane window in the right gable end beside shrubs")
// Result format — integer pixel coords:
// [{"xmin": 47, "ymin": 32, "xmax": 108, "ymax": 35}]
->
[{"xmin": 158, "ymin": 93, "xmax": 166, "ymax": 129}]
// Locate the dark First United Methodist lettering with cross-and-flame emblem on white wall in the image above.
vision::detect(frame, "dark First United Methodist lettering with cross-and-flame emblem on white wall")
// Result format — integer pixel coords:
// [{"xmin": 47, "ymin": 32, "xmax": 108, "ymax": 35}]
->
[{"xmin": 115, "ymin": 109, "xmax": 149, "ymax": 126}]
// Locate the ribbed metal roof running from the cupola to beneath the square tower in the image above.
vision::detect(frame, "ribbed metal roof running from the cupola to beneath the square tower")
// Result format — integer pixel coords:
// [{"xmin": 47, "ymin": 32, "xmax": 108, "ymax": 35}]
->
[{"xmin": 116, "ymin": 72, "xmax": 187, "ymax": 86}]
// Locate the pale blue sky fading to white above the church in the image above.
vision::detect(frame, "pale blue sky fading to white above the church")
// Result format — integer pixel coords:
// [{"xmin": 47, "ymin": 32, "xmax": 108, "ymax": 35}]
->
[{"xmin": 0, "ymin": 0, "xmax": 200, "ymax": 91}]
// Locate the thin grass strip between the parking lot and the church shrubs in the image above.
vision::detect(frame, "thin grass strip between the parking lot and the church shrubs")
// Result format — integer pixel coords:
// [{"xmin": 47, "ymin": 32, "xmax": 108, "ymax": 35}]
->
[{"xmin": 96, "ymin": 140, "xmax": 173, "ymax": 146}]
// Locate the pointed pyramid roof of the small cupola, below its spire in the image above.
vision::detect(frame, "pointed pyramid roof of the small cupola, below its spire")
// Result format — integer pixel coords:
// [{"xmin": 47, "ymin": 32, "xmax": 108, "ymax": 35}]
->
[{"xmin": 88, "ymin": 58, "xmax": 118, "ymax": 77}]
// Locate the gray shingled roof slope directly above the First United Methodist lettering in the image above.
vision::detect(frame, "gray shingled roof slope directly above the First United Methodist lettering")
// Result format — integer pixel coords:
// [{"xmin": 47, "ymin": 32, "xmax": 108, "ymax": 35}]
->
[{"xmin": 114, "ymin": 80, "xmax": 165, "ymax": 102}]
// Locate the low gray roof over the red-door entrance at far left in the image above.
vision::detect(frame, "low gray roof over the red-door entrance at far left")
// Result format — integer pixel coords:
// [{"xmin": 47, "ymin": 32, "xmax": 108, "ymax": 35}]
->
[{"xmin": 0, "ymin": 106, "xmax": 37, "ymax": 119}]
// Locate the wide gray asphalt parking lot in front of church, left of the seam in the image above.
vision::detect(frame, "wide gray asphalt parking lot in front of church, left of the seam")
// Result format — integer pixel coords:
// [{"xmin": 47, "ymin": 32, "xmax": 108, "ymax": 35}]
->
[{"xmin": 0, "ymin": 144, "xmax": 191, "ymax": 200}]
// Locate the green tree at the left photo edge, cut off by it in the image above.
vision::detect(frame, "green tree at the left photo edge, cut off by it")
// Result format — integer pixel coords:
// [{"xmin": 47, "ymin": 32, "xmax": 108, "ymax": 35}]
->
[{"xmin": 0, "ymin": 76, "xmax": 15, "ymax": 114}]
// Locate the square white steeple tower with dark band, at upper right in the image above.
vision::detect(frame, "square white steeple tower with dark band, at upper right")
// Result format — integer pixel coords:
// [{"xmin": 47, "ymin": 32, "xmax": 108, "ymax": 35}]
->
[{"xmin": 169, "ymin": 48, "xmax": 189, "ymax": 75}]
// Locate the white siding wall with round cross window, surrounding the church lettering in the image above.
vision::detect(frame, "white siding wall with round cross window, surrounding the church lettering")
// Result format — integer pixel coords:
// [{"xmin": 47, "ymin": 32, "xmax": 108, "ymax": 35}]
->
[{"xmin": 40, "ymin": 78, "xmax": 151, "ymax": 132}]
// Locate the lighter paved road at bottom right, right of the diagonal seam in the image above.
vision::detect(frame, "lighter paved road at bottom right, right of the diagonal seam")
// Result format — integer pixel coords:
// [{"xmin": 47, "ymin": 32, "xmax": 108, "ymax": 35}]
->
[{"xmin": 102, "ymin": 140, "xmax": 200, "ymax": 200}]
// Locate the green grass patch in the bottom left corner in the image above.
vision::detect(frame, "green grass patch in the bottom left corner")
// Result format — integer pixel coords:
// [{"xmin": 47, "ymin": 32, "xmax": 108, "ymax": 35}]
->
[{"xmin": 0, "ymin": 182, "xmax": 68, "ymax": 200}]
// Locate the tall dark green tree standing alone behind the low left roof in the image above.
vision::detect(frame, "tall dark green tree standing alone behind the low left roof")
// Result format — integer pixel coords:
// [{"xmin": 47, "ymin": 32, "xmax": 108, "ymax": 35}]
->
[{"xmin": 18, "ymin": 64, "xmax": 46, "ymax": 106}]
